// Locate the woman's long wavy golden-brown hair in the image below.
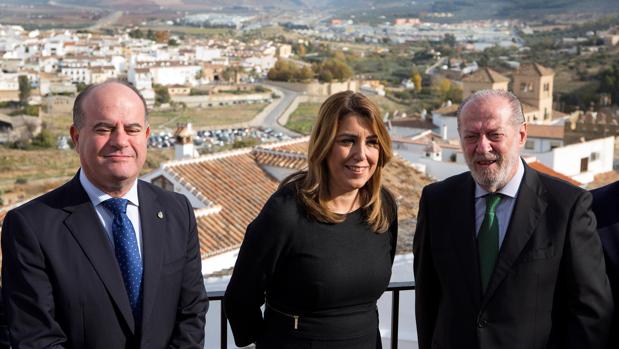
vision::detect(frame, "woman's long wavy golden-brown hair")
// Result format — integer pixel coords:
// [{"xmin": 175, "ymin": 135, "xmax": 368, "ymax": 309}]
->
[{"xmin": 280, "ymin": 91, "xmax": 395, "ymax": 233}]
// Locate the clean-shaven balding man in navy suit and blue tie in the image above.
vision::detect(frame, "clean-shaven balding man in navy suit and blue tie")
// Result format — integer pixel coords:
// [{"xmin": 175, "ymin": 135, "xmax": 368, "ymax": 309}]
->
[{"xmin": 2, "ymin": 81, "xmax": 208, "ymax": 349}]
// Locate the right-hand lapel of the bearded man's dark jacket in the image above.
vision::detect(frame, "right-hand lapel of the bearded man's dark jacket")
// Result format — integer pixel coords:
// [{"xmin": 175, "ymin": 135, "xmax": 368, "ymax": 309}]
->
[{"xmin": 482, "ymin": 164, "xmax": 547, "ymax": 307}]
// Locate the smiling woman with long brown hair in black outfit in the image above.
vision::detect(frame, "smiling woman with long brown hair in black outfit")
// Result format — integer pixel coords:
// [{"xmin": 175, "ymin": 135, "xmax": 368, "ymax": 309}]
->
[{"xmin": 224, "ymin": 91, "xmax": 397, "ymax": 349}]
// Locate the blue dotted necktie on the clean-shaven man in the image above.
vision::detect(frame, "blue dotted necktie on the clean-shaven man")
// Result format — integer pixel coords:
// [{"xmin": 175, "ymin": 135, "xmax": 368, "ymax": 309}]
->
[{"xmin": 101, "ymin": 198, "xmax": 142, "ymax": 322}]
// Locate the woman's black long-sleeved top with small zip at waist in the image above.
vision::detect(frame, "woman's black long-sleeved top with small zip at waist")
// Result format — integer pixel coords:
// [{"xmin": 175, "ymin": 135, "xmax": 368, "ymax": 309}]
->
[{"xmin": 224, "ymin": 184, "xmax": 397, "ymax": 348}]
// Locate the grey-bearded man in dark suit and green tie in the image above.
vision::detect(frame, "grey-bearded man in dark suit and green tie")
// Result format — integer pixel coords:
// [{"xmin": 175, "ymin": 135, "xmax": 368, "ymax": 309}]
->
[{"xmin": 413, "ymin": 90, "xmax": 613, "ymax": 349}]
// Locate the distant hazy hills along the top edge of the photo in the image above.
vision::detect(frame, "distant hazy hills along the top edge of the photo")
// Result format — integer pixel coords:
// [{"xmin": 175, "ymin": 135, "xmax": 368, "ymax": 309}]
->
[{"xmin": 7, "ymin": 0, "xmax": 619, "ymax": 19}]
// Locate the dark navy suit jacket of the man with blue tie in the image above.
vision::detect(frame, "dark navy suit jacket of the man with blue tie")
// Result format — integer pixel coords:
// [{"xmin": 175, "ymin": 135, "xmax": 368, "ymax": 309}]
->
[{"xmin": 2, "ymin": 176, "xmax": 208, "ymax": 349}]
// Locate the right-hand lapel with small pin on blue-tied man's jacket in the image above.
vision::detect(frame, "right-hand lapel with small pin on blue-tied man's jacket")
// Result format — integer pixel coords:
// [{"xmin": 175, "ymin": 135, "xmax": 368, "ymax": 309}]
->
[{"xmin": 138, "ymin": 181, "xmax": 168, "ymax": 326}]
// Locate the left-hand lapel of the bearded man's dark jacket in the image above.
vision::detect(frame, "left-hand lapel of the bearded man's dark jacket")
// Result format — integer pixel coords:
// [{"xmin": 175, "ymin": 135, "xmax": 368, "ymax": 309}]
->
[{"xmin": 450, "ymin": 174, "xmax": 481, "ymax": 306}]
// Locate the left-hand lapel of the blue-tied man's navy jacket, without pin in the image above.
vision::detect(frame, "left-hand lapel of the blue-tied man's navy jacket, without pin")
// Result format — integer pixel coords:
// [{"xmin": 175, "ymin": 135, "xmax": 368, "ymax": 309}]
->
[{"xmin": 65, "ymin": 176, "xmax": 135, "ymax": 332}]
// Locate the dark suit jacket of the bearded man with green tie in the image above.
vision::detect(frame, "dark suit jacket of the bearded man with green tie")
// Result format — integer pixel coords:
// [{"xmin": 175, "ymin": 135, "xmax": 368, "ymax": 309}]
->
[{"xmin": 413, "ymin": 165, "xmax": 613, "ymax": 349}]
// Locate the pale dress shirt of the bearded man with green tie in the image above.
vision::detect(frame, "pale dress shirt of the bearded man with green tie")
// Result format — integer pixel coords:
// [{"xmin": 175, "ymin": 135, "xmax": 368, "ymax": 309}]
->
[{"xmin": 475, "ymin": 159, "xmax": 524, "ymax": 248}]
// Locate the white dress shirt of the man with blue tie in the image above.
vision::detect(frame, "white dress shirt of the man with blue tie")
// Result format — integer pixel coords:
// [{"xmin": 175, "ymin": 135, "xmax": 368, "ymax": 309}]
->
[{"xmin": 80, "ymin": 169, "xmax": 142, "ymax": 257}]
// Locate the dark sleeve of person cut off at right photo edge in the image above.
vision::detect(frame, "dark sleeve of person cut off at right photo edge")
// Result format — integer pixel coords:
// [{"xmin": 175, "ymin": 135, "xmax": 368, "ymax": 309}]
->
[{"xmin": 591, "ymin": 181, "xmax": 619, "ymax": 349}]
